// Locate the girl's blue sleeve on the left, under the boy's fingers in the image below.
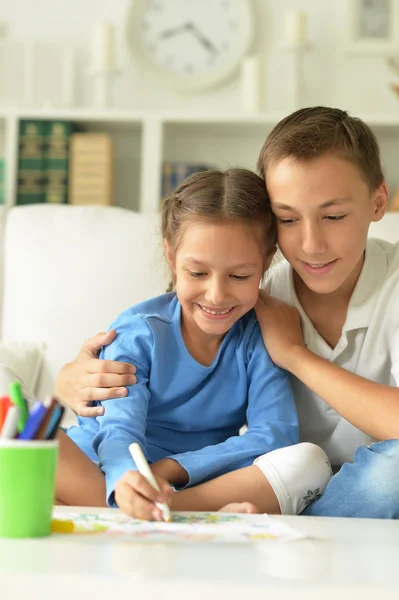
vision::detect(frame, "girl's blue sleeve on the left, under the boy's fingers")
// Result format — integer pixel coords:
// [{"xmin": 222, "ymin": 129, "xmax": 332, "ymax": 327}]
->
[{"xmin": 93, "ymin": 314, "xmax": 153, "ymax": 506}]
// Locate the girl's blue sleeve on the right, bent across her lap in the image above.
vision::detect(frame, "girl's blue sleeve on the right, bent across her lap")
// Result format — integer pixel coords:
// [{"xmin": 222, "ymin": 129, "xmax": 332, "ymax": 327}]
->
[{"xmin": 169, "ymin": 327, "xmax": 298, "ymax": 486}]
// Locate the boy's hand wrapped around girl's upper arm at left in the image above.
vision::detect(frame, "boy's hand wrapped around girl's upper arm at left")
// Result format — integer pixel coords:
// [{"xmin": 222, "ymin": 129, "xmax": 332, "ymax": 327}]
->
[{"xmin": 55, "ymin": 330, "xmax": 136, "ymax": 417}]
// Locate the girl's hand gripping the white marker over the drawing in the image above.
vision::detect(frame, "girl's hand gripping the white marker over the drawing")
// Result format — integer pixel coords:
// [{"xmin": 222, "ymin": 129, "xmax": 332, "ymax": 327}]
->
[{"xmin": 115, "ymin": 471, "xmax": 173, "ymax": 521}]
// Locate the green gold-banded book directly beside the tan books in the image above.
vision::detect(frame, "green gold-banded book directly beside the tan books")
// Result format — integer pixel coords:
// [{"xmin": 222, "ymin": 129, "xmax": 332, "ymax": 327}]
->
[{"xmin": 43, "ymin": 121, "xmax": 75, "ymax": 204}]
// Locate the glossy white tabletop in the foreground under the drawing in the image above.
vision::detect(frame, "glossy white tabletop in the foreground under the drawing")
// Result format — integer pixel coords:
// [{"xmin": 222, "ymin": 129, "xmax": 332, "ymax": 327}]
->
[{"xmin": 0, "ymin": 507, "xmax": 399, "ymax": 600}]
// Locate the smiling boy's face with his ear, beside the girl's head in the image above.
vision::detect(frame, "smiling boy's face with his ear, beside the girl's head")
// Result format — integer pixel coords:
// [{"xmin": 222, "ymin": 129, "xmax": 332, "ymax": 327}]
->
[{"xmin": 267, "ymin": 154, "xmax": 387, "ymax": 295}]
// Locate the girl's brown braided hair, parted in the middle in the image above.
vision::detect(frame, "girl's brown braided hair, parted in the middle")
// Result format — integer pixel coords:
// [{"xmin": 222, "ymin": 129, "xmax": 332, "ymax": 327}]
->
[{"xmin": 161, "ymin": 169, "xmax": 277, "ymax": 291}]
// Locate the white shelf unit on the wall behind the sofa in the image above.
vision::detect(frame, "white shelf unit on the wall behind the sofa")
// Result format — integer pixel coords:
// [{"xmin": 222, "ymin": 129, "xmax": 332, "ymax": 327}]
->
[{"xmin": 0, "ymin": 108, "xmax": 399, "ymax": 213}]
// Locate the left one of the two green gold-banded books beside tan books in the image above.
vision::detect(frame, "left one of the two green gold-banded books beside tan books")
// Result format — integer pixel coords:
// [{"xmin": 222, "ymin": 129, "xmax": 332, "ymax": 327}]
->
[{"xmin": 17, "ymin": 119, "xmax": 46, "ymax": 204}]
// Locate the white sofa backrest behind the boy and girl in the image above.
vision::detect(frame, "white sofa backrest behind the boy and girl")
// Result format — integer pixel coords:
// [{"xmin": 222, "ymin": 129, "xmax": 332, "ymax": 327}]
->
[{"xmin": 0, "ymin": 205, "xmax": 399, "ymax": 426}]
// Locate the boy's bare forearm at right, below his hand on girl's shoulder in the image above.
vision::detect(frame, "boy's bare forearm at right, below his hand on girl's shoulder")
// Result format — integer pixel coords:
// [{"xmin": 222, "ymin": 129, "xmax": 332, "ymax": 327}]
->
[{"xmin": 287, "ymin": 346, "xmax": 399, "ymax": 440}]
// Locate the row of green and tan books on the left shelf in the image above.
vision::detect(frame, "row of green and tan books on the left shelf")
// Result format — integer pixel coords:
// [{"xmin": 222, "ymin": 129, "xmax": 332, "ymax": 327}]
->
[{"xmin": 14, "ymin": 119, "xmax": 113, "ymax": 204}]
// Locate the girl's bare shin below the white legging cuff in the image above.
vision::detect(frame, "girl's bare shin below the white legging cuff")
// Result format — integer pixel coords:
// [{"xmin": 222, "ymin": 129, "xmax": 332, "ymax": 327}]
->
[{"xmin": 171, "ymin": 465, "xmax": 280, "ymax": 514}]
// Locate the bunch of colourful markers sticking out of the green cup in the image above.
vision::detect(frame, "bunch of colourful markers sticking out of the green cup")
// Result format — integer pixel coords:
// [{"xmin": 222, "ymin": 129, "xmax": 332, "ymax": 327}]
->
[{"xmin": 0, "ymin": 381, "xmax": 65, "ymax": 441}]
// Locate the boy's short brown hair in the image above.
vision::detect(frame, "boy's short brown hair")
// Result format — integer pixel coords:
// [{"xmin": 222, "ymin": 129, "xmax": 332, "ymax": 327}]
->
[{"xmin": 257, "ymin": 106, "xmax": 384, "ymax": 190}]
